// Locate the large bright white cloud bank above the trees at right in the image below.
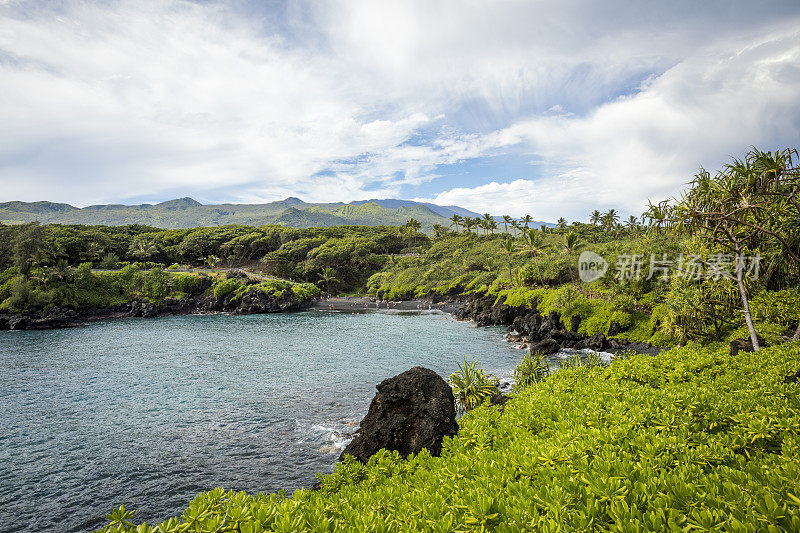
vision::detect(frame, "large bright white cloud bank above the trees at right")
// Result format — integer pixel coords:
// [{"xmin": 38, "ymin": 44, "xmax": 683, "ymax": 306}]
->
[{"xmin": 418, "ymin": 28, "xmax": 800, "ymax": 220}]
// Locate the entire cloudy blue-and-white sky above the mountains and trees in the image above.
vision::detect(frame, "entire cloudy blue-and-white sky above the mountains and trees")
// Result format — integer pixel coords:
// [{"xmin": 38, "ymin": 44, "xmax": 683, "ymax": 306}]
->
[{"xmin": 0, "ymin": 0, "xmax": 800, "ymax": 220}]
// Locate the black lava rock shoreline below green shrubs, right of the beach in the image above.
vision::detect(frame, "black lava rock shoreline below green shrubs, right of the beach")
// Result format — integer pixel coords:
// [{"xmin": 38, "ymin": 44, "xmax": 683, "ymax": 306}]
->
[{"xmin": 455, "ymin": 296, "xmax": 662, "ymax": 355}]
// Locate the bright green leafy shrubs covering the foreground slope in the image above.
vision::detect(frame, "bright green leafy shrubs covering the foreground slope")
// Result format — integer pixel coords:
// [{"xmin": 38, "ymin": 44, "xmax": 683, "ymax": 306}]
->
[{"xmin": 101, "ymin": 343, "xmax": 800, "ymax": 533}]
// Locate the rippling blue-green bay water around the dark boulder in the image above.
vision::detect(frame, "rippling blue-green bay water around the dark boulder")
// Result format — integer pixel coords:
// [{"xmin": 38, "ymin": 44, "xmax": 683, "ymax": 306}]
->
[{"xmin": 0, "ymin": 312, "xmax": 524, "ymax": 532}]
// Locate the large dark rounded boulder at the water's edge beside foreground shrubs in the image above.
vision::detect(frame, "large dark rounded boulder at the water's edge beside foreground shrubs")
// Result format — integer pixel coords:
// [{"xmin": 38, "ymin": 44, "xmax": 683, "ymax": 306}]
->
[{"xmin": 339, "ymin": 366, "xmax": 458, "ymax": 463}]
